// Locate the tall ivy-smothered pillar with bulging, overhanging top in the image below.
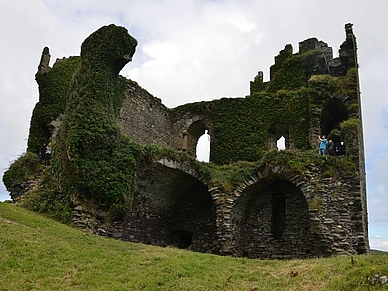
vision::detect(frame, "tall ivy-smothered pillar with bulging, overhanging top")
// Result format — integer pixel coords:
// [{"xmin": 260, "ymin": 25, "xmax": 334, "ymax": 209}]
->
[{"xmin": 50, "ymin": 25, "xmax": 138, "ymax": 216}]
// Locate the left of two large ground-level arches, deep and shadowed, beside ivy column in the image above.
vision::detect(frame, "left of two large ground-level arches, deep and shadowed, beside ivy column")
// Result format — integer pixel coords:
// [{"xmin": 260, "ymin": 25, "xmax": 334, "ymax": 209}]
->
[{"xmin": 125, "ymin": 159, "xmax": 217, "ymax": 253}]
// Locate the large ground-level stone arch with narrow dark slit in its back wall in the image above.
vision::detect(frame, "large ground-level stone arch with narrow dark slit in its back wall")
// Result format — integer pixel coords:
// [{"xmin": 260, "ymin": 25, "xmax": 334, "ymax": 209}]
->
[{"xmin": 233, "ymin": 167, "xmax": 326, "ymax": 259}]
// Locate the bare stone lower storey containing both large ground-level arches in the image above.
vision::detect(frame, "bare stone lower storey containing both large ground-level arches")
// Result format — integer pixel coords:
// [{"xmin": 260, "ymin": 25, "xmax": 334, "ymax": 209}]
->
[{"xmin": 73, "ymin": 163, "xmax": 369, "ymax": 259}]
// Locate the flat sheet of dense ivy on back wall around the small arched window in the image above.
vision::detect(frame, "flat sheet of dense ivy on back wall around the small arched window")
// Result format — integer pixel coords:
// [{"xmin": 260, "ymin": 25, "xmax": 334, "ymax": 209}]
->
[{"xmin": 173, "ymin": 88, "xmax": 309, "ymax": 165}]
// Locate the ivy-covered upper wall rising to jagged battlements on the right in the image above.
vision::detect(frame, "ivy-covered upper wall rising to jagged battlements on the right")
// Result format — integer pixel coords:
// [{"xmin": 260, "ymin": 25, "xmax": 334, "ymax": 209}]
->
[{"xmin": 172, "ymin": 25, "xmax": 361, "ymax": 164}]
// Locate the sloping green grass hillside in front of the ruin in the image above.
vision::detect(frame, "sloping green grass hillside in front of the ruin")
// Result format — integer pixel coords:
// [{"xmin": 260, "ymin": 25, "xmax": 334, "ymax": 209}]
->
[{"xmin": 0, "ymin": 203, "xmax": 388, "ymax": 291}]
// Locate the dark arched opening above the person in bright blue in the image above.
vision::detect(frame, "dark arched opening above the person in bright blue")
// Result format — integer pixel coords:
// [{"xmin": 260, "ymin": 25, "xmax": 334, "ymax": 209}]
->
[{"xmin": 320, "ymin": 97, "xmax": 349, "ymax": 136}]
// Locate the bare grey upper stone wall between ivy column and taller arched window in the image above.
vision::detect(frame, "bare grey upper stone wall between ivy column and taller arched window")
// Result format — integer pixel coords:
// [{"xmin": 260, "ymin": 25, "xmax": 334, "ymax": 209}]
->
[{"xmin": 117, "ymin": 80, "xmax": 211, "ymax": 161}]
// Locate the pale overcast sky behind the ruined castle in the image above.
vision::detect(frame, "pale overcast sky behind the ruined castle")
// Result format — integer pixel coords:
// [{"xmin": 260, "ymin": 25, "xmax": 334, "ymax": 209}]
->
[{"xmin": 0, "ymin": 0, "xmax": 388, "ymax": 251}]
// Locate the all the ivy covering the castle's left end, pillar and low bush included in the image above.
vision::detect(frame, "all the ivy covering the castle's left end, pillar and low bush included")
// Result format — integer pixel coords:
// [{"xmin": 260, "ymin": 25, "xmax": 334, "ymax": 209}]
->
[{"xmin": 3, "ymin": 25, "xmax": 141, "ymax": 221}]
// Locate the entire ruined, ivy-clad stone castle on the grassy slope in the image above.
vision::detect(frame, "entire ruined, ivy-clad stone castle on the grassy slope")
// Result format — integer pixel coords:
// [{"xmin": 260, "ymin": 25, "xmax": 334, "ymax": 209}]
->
[{"xmin": 7, "ymin": 24, "xmax": 369, "ymax": 258}]
